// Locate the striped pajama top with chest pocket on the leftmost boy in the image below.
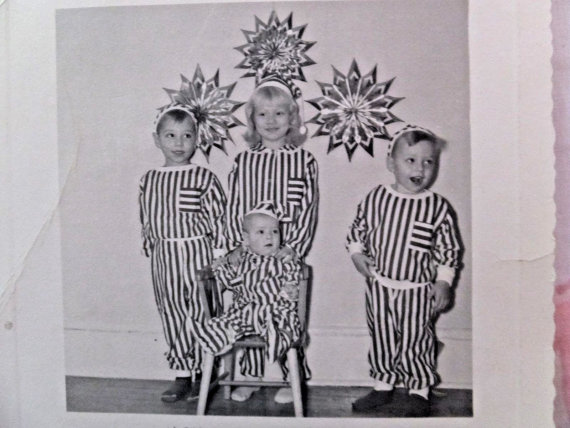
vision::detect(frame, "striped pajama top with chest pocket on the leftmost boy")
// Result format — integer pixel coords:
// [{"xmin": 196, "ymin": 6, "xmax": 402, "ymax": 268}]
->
[{"xmin": 139, "ymin": 164, "xmax": 226, "ymax": 257}]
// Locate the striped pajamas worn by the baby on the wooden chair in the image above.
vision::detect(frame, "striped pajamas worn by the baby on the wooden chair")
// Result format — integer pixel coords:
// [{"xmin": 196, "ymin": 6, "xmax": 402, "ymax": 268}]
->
[{"xmin": 189, "ymin": 252, "xmax": 301, "ymax": 376}]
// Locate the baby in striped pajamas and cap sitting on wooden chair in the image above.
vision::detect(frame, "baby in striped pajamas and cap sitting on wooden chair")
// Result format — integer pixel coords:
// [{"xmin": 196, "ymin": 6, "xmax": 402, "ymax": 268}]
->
[{"xmin": 188, "ymin": 207, "xmax": 301, "ymax": 389}]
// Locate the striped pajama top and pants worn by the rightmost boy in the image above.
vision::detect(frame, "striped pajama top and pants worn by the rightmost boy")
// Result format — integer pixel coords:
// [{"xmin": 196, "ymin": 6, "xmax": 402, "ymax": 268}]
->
[{"xmin": 347, "ymin": 185, "xmax": 462, "ymax": 389}]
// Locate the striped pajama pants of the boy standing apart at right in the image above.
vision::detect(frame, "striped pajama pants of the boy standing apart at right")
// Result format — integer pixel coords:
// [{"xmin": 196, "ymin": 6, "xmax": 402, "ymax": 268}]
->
[{"xmin": 366, "ymin": 278, "xmax": 439, "ymax": 389}]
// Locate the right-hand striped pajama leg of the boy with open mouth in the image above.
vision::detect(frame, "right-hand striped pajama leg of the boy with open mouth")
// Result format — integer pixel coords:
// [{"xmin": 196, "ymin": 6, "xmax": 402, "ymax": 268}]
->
[{"xmin": 392, "ymin": 286, "xmax": 439, "ymax": 392}]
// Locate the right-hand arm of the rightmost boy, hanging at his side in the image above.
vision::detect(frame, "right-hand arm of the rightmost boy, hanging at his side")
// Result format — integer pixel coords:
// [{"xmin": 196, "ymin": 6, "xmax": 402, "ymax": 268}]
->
[{"xmin": 430, "ymin": 205, "xmax": 463, "ymax": 312}]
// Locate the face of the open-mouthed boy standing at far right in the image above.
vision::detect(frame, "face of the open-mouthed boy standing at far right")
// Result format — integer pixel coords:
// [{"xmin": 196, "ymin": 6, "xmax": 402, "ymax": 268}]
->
[{"xmin": 387, "ymin": 140, "xmax": 439, "ymax": 194}]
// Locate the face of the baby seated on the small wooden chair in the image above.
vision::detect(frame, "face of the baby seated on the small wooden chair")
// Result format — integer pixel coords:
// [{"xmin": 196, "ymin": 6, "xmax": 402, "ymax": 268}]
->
[{"xmin": 243, "ymin": 214, "xmax": 280, "ymax": 256}]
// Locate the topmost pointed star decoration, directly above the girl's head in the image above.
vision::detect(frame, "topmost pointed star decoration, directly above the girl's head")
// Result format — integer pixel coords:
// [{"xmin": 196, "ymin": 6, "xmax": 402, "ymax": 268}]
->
[{"xmin": 235, "ymin": 11, "xmax": 316, "ymax": 82}]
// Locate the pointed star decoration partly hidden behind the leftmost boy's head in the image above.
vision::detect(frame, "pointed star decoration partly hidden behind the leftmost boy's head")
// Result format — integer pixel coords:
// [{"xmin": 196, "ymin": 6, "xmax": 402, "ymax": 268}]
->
[{"xmin": 164, "ymin": 65, "xmax": 245, "ymax": 160}]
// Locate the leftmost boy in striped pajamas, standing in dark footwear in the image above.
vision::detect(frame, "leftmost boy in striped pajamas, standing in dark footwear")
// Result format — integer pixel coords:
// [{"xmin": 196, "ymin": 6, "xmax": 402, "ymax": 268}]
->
[{"xmin": 139, "ymin": 103, "xmax": 226, "ymax": 402}]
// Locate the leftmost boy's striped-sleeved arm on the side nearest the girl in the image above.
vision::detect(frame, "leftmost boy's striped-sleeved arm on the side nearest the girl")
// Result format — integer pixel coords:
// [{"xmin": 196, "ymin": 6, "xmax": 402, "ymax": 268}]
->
[{"xmin": 204, "ymin": 174, "xmax": 226, "ymax": 258}]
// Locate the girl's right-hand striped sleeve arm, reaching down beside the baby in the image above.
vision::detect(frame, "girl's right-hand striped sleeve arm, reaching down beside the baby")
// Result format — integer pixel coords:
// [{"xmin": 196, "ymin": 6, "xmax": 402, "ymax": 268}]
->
[{"xmin": 282, "ymin": 152, "xmax": 319, "ymax": 258}]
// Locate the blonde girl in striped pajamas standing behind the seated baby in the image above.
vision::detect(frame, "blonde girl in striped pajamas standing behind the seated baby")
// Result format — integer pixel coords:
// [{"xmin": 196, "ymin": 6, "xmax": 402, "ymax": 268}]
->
[{"xmin": 227, "ymin": 79, "xmax": 318, "ymax": 402}]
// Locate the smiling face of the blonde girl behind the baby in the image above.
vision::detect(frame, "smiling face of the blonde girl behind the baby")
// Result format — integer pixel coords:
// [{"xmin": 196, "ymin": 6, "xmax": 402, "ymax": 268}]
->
[{"xmin": 253, "ymin": 98, "xmax": 291, "ymax": 148}]
